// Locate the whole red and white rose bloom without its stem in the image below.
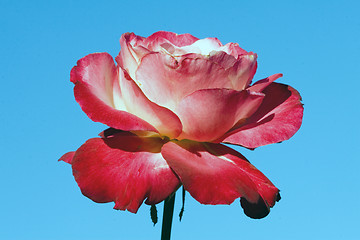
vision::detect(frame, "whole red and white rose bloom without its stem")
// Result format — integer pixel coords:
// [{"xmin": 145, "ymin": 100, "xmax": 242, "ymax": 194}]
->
[{"xmin": 61, "ymin": 32, "xmax": 303, "ymax": 218}]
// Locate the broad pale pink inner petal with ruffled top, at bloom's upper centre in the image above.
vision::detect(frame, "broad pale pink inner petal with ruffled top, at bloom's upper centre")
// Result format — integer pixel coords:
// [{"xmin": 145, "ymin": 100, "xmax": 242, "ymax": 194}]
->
[{"xmin": 136, "ymin": 53, "xmax": 231, "ymax": 110}]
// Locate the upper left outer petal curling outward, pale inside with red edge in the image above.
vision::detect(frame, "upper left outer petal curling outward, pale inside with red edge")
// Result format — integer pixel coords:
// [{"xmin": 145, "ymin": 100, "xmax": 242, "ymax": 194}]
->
[{"xmin": 70, "ymin": 53, "xmax": 156, "ymax": 131}]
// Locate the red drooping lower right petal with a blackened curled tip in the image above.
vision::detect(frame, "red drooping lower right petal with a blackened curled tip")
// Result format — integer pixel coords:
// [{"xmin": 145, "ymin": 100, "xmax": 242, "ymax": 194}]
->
[{"xmin": 161, "ymin": 140, "xmax": 279, "ymax": 218}]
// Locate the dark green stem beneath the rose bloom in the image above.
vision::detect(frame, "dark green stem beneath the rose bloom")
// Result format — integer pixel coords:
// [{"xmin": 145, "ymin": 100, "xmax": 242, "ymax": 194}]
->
[{"xmin": 161, "ymin": 193, "xmax": 175, "ymax": 240}]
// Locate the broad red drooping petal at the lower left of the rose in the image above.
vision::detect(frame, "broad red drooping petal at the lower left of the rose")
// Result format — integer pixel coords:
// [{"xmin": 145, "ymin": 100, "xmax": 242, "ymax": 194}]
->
[{"xmin": 62, "ymin": 132, "xmax": 180, "ymax": 213}]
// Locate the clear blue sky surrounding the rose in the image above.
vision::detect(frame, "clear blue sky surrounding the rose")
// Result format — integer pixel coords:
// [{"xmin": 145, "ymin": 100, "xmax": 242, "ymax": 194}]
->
[{"xmin": 0, "ymin": 0, "xmax": 360, "ymax": 240}]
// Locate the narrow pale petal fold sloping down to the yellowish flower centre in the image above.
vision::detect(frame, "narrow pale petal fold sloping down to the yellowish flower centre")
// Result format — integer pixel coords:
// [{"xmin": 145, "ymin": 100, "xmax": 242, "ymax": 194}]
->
[{"xmin": 119, "ymin": 69, "xmax": 182, "ymax": 138}]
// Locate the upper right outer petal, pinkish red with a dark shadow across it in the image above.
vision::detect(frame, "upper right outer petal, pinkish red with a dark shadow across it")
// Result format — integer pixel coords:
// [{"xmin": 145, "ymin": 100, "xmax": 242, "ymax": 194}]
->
[{"xmin": 219, "ymin": 83, "xmax": 304, "ymax": 148}]
